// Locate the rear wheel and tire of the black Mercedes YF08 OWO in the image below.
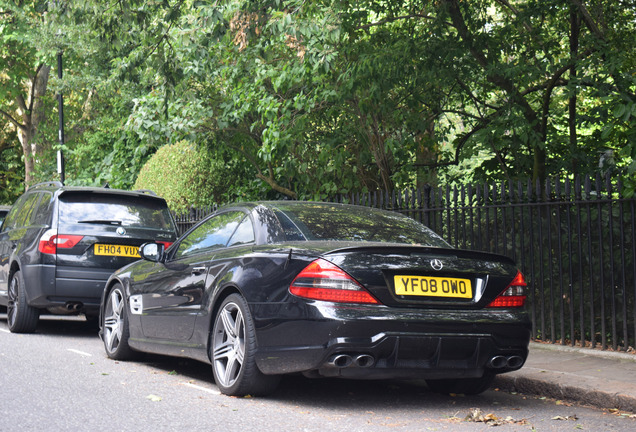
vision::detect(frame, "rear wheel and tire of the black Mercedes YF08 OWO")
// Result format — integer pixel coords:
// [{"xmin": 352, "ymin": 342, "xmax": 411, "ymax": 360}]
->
[{"xmin": 209, "ymin": 294, "xmax": 280, "ymax": 396}]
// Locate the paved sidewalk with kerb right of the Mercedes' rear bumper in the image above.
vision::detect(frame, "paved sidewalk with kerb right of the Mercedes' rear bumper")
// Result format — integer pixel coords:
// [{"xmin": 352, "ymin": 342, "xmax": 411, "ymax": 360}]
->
[{"xmin": 494, "ymin": 342, "xmax": 636, "ymax": 413}]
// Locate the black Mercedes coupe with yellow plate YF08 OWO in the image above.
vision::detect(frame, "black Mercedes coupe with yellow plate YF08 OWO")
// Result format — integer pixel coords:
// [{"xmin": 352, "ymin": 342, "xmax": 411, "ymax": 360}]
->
[{"xmin": 100, "ymin": 201, "xmax": 530, "ymax": 395}]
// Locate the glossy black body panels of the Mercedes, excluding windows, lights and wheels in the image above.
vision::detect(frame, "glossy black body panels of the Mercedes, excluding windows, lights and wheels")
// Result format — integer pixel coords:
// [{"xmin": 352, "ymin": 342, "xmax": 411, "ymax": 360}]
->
[{"xmin": 102, "ymin": 202, "xmax": 530, "ymax": 378}]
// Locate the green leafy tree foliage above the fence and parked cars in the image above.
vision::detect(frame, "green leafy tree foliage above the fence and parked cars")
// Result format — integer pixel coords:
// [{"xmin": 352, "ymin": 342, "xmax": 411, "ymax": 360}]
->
[{"xmin": 0, "ymin": 0, "xmax": 636, "ymax": 199}]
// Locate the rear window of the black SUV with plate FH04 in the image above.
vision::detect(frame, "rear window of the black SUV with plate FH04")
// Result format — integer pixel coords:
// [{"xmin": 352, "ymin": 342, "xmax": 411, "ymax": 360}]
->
[{"xmin": 59, "ymin": 194, "xmax": 175, "ymax": 231}]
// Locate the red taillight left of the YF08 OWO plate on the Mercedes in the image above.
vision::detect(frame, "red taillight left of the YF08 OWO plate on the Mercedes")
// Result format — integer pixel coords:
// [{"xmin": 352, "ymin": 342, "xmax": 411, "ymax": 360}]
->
[{"xmin": 289, "ymin": 259, "xmax": 380, "ymax": 304}]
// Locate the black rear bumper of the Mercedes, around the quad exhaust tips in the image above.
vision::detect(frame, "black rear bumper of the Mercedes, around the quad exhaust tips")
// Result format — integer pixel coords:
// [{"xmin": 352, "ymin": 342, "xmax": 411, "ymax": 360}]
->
[{"xmin": 251, "ymin": 302, "xmax": 531, "ymax": 378}]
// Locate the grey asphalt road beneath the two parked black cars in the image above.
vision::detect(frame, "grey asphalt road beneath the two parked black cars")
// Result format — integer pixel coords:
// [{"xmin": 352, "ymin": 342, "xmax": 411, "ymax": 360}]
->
[{"xmin": 0, "ymin": 314, "xmax": 636, "ymax": 432}]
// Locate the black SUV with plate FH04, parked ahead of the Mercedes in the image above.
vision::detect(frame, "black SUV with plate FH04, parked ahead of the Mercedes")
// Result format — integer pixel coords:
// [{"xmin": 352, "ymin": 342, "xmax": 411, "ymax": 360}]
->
[{"xmin": 0, "ymin": 182, "xmax": 177, "ymax": 333}]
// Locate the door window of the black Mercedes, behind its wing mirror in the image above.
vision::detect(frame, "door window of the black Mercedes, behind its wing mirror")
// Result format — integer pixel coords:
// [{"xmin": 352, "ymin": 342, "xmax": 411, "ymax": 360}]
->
[{"xmin": 175, "ymin": 211, "xmax": 245, "ymax": 258}]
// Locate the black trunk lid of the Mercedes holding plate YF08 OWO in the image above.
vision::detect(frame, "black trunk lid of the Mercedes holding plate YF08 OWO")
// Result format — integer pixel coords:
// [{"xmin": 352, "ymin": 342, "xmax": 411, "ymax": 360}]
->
[{"xmin": 322, "ymin": 245, "xmax": 517, "ymax": 309}]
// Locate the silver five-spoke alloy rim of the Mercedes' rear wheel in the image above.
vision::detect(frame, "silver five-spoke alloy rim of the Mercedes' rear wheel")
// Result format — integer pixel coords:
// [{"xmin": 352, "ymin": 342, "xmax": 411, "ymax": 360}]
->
[{"xmin": 212, "ymin": 302, "xmax": 245, "ymax": 387}]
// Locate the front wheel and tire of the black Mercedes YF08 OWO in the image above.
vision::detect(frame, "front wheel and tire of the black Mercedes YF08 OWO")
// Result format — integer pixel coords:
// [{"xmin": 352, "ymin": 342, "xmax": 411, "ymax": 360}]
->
[{"xmin": 102, "ymin": 284, "xmax": 137, "ymax": 360}]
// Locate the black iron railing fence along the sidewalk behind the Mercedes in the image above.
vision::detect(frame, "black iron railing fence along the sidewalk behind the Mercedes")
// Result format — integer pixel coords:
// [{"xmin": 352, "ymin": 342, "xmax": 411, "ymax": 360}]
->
[{"xmin": 173, "ymin": 177, "xmax": 636, "ymax": 351}]
